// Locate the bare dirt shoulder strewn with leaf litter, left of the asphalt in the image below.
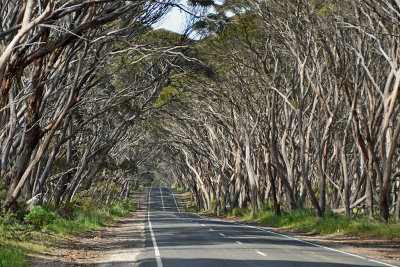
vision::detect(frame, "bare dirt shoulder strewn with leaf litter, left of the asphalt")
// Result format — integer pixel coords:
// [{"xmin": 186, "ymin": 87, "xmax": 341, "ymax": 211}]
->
[{"xmin": 30, "ymin": 191, "xmax": 146, "ymax": 267}]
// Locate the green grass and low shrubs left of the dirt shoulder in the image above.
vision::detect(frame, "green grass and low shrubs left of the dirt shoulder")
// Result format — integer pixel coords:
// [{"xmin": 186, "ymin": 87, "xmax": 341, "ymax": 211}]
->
[{"xmin": 0, "ymin": 201, "xmax": 136, "ymax": 267}]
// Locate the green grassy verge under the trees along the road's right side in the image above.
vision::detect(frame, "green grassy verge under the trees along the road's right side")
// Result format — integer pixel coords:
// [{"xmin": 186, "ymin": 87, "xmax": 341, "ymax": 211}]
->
[{"xmin": 173, "ymin": 185, "xmax": 400, "ymax": 239}]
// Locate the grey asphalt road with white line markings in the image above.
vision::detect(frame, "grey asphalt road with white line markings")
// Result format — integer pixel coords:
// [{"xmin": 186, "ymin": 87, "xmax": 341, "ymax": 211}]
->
[{"xmin": 139, "ymin": 188, "xmax": 394, "ymax": 267}]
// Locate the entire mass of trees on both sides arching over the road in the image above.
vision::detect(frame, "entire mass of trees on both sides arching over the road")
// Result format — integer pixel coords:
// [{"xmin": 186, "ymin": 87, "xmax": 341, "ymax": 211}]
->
[{"xmin": 0, "ymin": 0, "xmax": 400, "ymax": 224}]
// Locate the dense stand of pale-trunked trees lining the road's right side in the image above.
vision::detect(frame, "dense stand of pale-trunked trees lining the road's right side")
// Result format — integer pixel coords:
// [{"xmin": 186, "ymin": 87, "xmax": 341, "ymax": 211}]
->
[{"xmin": 148, "ymin": 0, "xmax": 400, "ymax": 224}]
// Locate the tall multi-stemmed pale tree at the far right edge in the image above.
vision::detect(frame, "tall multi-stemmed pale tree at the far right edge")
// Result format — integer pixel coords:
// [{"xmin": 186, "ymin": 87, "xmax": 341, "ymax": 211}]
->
[{"xmin": 343, "ymin": 1, "xmax": 400, "ymax": 221}]
